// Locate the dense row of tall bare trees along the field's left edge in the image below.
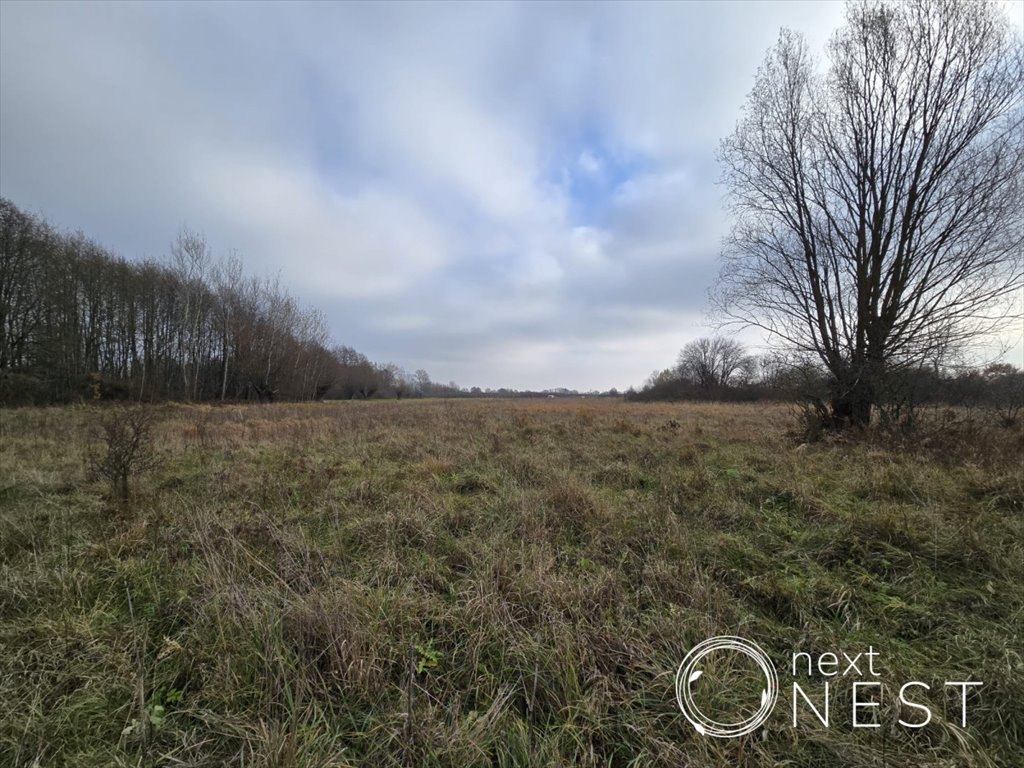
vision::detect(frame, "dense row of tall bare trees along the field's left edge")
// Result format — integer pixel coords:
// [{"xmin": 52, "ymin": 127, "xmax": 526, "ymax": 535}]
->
[{"xmin": 0, "ymin": 200, "xmax": 407, "ymax": 402}]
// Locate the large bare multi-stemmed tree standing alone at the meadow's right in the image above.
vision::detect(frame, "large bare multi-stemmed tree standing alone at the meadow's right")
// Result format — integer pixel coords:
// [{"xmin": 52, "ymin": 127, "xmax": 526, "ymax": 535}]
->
[{"xmin": 714, "ymin": 0, "xmax": 1024, "ymax": 425}]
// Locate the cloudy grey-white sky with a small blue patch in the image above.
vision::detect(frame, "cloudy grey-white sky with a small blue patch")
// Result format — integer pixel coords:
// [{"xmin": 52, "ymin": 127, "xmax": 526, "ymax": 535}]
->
[{"xmin": 0, "ymin": 0, "xmax": 1024, "ymax": 390}]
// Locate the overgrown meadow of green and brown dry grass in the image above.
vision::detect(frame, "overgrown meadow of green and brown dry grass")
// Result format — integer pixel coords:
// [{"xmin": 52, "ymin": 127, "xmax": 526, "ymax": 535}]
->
[{"xmin": 0, "ymin": 399, "xmax": 1024, "ymax": 767}]
